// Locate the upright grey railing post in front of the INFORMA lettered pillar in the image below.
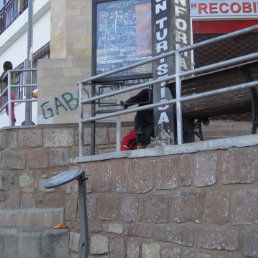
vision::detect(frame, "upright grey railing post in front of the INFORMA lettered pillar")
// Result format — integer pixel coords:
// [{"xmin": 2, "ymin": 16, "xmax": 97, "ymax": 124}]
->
[{"xmin": 175, "ymin": 51, "xmax": 183, "ymax": 144}]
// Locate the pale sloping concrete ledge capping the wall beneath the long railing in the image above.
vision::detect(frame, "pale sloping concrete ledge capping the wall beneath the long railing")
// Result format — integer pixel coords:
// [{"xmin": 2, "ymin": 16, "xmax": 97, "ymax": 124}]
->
[{"xmin": 70, "ymin": 134, "xmax": 258, "ymax": 163}]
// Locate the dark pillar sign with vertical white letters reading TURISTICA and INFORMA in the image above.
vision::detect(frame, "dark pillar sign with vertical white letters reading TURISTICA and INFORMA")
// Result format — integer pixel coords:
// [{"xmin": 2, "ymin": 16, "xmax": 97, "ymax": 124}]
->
[{"xmin": 152, "ymin": 0, "xmax": 191, "ymax": 145}]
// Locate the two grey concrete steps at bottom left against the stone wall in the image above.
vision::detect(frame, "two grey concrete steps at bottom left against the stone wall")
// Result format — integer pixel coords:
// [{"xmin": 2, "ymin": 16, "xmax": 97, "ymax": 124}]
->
[{"xmin": 0, "ymin": 208, "xmax": 69, "ymax": 258}]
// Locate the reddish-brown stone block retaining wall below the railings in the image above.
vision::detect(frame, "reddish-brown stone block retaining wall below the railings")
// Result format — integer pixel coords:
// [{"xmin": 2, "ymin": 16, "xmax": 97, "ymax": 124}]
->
[{"xmin": 0, "ymin": 125, "xmax": 258, "ymax": 258}]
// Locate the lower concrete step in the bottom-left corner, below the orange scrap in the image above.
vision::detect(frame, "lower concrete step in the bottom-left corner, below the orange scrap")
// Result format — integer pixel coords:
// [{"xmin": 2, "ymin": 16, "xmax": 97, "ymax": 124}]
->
[{"xmin": 0, "ymin": 227, "xmax": 69, "ymax": 258}]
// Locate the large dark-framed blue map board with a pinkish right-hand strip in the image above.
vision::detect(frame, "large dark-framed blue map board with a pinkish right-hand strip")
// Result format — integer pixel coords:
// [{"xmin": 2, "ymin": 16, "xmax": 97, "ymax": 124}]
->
[{"xmin": 92, "ymin": 0, "xmax": 152, "ymax": 78}]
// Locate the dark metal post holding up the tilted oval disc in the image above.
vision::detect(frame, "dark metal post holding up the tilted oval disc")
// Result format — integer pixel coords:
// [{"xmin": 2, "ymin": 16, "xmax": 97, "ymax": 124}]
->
[{"xmin": 78, "ymin": 172, "xmax": 89, "ymax": 258}]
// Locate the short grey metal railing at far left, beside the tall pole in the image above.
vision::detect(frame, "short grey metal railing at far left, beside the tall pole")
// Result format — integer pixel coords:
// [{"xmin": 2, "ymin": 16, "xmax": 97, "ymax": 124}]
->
[{"xmin": 0, "ymin": 68, "xmax": 38, "ymax": 126}]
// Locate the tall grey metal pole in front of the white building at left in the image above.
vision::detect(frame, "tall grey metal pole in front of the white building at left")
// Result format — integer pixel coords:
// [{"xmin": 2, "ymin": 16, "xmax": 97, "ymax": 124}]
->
[{"xmin": 23, "ymin": 0, "xmax": 33, "ymax": 125}]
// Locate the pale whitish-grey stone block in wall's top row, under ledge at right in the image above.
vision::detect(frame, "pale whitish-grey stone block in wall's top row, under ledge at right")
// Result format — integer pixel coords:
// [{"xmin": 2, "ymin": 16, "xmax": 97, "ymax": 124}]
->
[{"xmin": 193, "ymin": 153, "xmax": 217, "ymax": 186}]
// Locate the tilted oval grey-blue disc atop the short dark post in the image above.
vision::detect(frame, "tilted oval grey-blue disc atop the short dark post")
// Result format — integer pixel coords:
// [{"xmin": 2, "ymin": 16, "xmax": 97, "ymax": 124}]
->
[{"xmin": 43, "ymin": 169, "xmax": 83, "ymax": 188}]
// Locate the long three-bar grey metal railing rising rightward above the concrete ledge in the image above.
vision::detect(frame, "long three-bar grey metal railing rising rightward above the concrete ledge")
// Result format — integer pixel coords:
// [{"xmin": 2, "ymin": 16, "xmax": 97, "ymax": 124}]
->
[{"xmin": 78, "ymin": 25, "xmax": 258, "ymax": 157}]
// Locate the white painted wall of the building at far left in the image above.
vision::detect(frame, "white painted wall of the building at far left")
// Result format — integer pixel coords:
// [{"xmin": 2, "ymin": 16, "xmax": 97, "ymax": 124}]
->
[{"xmin": 0, "ymin": 0, "xmax": 51, "ymax": 128}]
